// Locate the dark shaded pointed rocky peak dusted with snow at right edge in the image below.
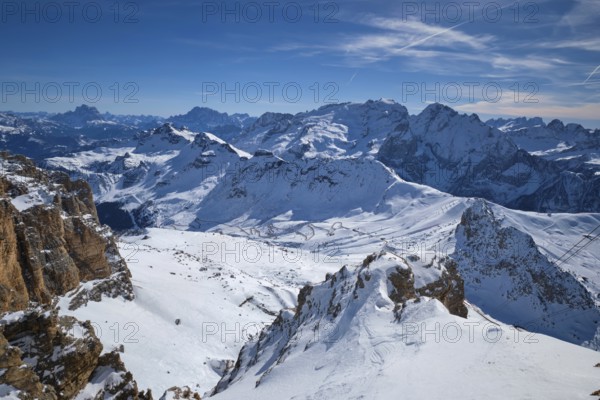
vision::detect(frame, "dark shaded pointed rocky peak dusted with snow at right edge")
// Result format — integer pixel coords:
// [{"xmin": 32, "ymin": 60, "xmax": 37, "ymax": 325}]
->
[{"xmin": 452, "ymin": 200, "xmax": 600, "ymax": 347}]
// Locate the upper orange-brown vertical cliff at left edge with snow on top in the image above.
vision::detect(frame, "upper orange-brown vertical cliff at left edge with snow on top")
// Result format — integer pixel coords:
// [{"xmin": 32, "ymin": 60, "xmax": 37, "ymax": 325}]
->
[{"xmin": 0, "ymin": 153, "xmax": 133, "ymax": 311}]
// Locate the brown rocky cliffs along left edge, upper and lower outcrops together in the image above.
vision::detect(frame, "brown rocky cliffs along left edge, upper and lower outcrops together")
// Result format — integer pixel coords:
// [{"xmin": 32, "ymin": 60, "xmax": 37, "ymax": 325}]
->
[{"xmin": 0, "ymin": 153, "xmax": 151, "ymax": 400}]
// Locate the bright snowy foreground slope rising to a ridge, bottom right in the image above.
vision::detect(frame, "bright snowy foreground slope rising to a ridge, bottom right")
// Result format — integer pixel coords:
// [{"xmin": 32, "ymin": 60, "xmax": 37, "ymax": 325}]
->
[{"xmin": 214, "ymin": 255, "xmax": 597, "ymax": 399}]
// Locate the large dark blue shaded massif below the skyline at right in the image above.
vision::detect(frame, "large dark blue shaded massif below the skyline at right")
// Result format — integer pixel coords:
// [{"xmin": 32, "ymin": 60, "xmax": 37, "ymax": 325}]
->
[{"xmin": 378, "ymin": 104, "xmax": 600, "ymax": 212}]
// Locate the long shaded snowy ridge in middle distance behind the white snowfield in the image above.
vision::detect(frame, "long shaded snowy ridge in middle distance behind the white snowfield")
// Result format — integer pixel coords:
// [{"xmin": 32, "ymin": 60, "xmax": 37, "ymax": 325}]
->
[{"xmin": 48, "ymin": 120, "xmax": 436, "ymax": 230}]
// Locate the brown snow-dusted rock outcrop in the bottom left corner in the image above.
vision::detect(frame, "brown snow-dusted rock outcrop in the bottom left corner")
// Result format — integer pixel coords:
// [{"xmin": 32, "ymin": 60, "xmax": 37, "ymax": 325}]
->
[{"xmin": 0, "ymin": 308, "xmax": 151, "ymax": 400}]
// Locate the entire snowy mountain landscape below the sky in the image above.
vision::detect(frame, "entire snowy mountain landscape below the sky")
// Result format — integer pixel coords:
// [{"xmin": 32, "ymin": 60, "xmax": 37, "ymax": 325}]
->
[{"xmin": 0, "ymin": 99, "xmax": 600, "ymax": 399}]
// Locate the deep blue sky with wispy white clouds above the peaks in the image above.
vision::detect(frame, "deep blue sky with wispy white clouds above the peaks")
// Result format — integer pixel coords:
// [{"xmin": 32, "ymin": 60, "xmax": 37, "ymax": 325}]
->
[{"xmin": 0, "ymin": 0, "xmax": 600, "ymax": 127}]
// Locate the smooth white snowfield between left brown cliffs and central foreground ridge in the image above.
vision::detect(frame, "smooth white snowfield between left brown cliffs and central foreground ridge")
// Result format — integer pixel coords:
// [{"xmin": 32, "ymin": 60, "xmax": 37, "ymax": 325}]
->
[{"xmin": 59, "ymin": 229, "xmax": 339, "ymax": 395}]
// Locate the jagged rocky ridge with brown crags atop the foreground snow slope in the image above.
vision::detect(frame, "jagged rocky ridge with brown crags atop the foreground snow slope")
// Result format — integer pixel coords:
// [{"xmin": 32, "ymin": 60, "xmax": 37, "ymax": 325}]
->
[{"xmin": 214, "ymin": 252, "xmax": 467, "ymax": 393}]
